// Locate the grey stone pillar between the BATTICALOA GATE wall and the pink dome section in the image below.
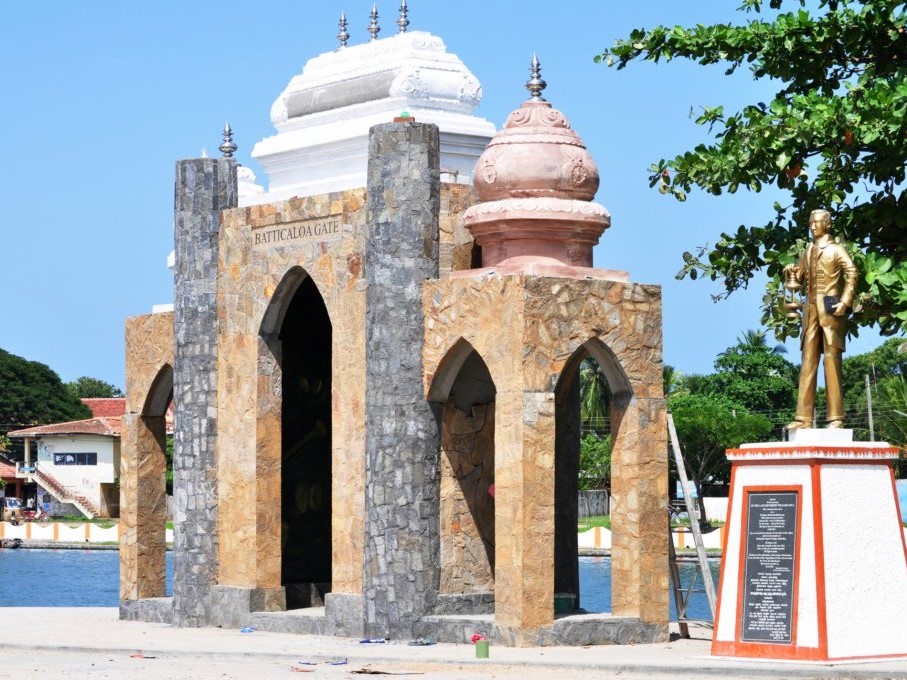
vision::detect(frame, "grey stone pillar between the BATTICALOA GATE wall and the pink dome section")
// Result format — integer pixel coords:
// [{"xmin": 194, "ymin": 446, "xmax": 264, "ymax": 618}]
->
[{"xmin": 363, "ymin": 123, "xmax": 441, "ymax": 638}]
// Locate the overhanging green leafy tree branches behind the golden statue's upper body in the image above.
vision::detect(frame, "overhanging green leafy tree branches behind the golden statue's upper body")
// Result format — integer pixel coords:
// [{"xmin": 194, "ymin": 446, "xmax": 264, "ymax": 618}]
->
[{"xmin": 596, "ymin": 0, "xmax": 907, "ymax": 337}]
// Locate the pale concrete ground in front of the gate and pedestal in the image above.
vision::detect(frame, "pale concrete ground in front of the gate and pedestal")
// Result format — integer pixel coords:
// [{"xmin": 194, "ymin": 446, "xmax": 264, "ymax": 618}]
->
[{"xmin": 0, "ymin": 608, "xmax": 907, "ymax": 680}]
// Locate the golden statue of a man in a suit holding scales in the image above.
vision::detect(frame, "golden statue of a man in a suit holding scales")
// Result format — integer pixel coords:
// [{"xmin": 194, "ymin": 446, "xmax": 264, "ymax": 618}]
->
[{"xmin": 785, "ymin": 210, "xmax": 857, "ymax": 430}]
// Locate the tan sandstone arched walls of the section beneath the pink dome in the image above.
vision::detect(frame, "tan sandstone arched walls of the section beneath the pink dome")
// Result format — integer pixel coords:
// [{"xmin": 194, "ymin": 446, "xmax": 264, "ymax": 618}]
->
[{"xmin": 423, "ymin": 272, "xmax": 668, "ymax": 644}]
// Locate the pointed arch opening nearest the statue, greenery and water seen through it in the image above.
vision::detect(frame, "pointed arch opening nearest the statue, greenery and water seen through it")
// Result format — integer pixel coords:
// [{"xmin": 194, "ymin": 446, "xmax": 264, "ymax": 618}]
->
[{"xmin": 554, "ymin": 339, "xmax": 632, "ymax": 614}]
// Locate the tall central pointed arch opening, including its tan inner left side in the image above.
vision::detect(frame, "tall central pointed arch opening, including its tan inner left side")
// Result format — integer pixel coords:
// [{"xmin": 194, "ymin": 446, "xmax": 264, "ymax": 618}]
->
[{"xmin": 256, "ymin": 267, "xmax": 333, "ymax": 609}]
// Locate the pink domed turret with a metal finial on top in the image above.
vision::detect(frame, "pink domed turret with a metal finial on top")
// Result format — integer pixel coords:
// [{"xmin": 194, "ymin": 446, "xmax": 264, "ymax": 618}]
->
[{"xmin": 464, "ymin": 57, "xmax": 611, "ymax": 267}]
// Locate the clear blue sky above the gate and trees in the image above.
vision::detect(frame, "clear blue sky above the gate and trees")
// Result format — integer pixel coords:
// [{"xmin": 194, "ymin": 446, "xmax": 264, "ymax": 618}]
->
[{"xmin": 0, "ymin": 0, "xmax": 879, "ymax": 386}]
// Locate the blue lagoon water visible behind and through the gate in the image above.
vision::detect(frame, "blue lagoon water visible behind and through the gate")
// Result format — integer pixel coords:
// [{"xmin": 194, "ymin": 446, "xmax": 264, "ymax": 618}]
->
[{"xmin": 0, "ymin": 549, "xmax": 718, "ymax": 619}]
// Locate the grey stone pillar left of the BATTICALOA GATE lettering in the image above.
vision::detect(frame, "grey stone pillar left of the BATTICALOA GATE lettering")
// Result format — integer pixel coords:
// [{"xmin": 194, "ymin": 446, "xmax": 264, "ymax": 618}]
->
[{"xmin": 173, "ymin": 158, "xmax": 237, "ymax": 627}]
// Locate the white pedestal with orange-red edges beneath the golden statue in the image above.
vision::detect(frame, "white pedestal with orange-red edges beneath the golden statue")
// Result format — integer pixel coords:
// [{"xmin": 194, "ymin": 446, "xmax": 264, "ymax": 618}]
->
[{"xmin": 712, "ymin": 430, "xmax": 907, "ymax": 661}]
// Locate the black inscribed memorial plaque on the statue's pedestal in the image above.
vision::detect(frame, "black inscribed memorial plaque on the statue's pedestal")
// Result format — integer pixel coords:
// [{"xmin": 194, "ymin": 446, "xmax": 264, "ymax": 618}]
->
[{"xmin": 740, "ymin": 491, "xmax": 798, "ymax": 644}]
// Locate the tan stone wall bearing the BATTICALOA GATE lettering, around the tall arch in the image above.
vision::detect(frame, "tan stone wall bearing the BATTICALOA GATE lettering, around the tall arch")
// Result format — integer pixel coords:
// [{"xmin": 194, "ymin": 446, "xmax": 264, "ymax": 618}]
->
[{"xmin": 217, "ymin": 189, "xmax": 366, "ymax": 608}]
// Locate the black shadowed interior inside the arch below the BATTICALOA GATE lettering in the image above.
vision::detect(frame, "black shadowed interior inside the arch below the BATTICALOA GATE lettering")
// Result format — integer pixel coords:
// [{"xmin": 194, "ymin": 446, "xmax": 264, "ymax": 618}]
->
[{"xmin": 279, "ymin": 277, "xmax": 332, "ymax": 609}]
